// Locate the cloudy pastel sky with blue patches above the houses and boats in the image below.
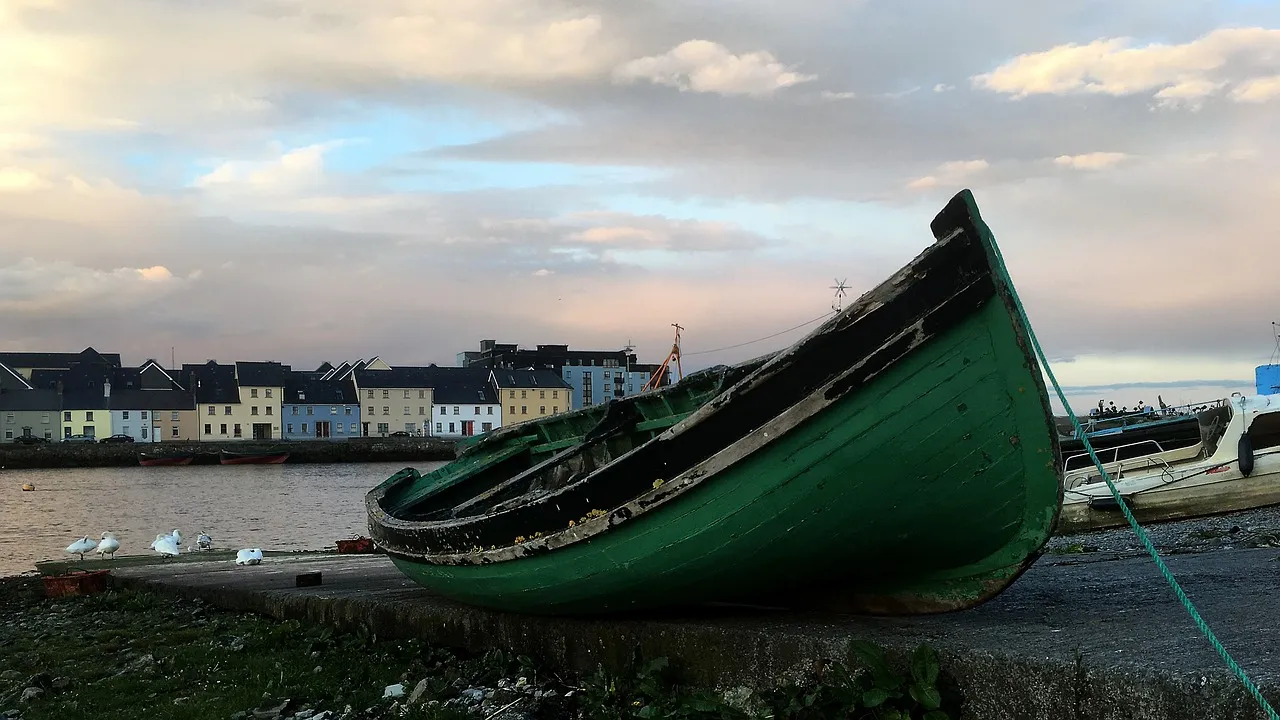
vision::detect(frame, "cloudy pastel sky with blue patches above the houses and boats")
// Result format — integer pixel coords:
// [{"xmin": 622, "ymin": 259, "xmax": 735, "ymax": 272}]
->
[{"xmin": 0, "ymin": 0, "xmax": 1280, "ymax": 409}]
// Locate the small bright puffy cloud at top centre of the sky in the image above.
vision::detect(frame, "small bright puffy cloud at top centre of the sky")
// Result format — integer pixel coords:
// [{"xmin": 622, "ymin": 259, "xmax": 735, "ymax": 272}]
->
[{"xmin": 613, "ymin": 40, "xmax": 818, "ymax": 97}]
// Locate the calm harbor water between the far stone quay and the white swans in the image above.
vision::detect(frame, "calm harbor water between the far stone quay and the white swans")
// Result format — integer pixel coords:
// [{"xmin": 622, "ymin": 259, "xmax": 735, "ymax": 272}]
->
[{"xmin": 0, "ymin": 461, "xmax": 443, "ymax": 577}]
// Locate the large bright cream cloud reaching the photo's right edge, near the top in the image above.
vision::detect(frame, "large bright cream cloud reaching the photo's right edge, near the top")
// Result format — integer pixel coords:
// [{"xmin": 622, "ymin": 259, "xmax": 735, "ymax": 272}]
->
[{"xmin": 972, "ymin": 27, "xmax": 1280, "ymax": 106}]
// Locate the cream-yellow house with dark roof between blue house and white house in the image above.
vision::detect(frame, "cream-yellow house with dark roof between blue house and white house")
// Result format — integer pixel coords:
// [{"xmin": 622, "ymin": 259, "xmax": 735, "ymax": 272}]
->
[{"xmin": 350, "ymin": 357, "xmax": 434, "ymax": 437}]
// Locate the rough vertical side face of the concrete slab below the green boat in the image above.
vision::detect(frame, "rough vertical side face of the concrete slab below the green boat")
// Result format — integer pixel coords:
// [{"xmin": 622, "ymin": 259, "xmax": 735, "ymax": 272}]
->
[{"xmin": 104, "ymin": 575, "xmax": 1280, "ymax": 720}]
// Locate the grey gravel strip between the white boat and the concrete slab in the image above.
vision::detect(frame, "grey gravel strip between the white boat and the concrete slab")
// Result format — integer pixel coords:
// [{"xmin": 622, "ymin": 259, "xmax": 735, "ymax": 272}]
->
[{"xmin": 1048, "ymin": 507, "xmax": 1280, "ymax": 555}]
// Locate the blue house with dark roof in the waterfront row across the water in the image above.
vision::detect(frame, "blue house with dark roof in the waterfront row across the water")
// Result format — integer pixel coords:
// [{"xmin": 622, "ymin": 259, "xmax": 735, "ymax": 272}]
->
[{"xmin": 280, "ymin": 370, "xmax": 360, "ymax": 441}]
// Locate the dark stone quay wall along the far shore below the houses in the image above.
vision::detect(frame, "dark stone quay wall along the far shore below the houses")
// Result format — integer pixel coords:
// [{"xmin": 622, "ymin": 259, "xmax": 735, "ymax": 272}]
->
[{"xmin": 0, "ymin": 438, "xmax": 456, "ymax": 470}]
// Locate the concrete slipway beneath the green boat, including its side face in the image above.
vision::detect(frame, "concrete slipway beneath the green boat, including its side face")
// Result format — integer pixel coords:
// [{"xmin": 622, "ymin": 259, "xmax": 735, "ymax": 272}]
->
[{"xmin": 102, "ymin": 550, "xmax": 1280, "ymax": 720}]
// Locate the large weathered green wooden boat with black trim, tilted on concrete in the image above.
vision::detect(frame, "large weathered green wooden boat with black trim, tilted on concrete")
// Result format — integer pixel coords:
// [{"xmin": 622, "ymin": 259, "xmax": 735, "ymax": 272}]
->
[{"xmin": 366, "ymin": 190, "xmax": 1062, "ymax": 614}]
